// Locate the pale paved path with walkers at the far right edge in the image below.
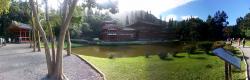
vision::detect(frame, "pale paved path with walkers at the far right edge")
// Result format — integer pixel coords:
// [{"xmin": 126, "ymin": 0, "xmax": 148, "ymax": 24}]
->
[{"xmin": 234, "ymin": 45, "xmax": 250, "ymax": 79}]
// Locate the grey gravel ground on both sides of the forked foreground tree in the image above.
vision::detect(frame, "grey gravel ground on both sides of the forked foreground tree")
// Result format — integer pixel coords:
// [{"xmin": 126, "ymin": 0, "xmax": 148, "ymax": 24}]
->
[{"xmin": 0, "ymin": 44, "xmax": 102, "ymax": 80}]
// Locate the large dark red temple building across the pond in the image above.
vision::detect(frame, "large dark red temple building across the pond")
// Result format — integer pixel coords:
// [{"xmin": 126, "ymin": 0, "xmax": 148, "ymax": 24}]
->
[{"xmin": 101, "ymin": 21, "xmax": 176, "ymax": 41}]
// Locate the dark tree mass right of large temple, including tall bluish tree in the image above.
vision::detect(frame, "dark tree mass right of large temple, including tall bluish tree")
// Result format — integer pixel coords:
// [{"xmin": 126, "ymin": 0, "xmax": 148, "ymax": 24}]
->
[{"xmin": 175, "ymin": 11, "xmax": 229, "ymax": 41}]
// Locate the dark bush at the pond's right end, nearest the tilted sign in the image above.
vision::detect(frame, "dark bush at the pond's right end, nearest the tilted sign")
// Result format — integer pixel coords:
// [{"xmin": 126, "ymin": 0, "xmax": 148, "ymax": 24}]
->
[{"xmin": 198, "ymin": 41, "xmax": 213, "ymax": 54}]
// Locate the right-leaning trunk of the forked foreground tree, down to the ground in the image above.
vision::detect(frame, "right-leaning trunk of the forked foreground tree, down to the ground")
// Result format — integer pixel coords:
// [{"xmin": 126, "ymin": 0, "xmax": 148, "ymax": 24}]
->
[{"xmin": 55, "ymin": 0, "xmax": 78, "ymax": 79}]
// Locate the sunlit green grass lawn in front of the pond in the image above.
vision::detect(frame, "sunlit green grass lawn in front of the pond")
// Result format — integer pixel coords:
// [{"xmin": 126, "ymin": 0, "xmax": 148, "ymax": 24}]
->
[{"xmin": 77, "ymin": 51, "xmax": 245, "ymax": 80}]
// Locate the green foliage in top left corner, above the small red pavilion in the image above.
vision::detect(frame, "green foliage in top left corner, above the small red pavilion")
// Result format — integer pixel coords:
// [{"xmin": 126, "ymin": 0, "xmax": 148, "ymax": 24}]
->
[{"xmin": 0, "ymin": 0, "xmax": 31, "ymax": 37}]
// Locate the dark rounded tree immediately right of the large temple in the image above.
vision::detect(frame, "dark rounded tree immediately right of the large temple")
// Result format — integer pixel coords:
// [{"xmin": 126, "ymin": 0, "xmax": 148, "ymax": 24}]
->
[{"xmin": 176, "ymin": 18, "xmax": 206, "ymax": 41}]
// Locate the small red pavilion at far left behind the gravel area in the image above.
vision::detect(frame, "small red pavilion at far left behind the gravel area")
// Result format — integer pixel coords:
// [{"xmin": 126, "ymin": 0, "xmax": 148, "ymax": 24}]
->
[{"xmin": 7, "ymin": 21, "xmax": 32, "ymax": 43}]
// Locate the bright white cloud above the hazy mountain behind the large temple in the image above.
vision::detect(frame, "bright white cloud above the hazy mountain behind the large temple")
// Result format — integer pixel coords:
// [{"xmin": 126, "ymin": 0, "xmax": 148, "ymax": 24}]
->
[{"xmin": 118, "ymin": 0, "xmax": 193, "ymax": 16}]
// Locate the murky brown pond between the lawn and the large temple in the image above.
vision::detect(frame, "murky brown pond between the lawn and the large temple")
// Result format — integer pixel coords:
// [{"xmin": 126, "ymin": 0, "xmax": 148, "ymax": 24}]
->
[{"xmin": 72, "ymin": 43, "xmax": 183, "ymax": 58}]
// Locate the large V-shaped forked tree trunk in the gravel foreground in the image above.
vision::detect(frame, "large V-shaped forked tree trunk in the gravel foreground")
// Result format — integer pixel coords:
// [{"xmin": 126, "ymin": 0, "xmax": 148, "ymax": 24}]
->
[{"xmin": 30, "ymin": 0, "xmax": 78, "ymax": 80}]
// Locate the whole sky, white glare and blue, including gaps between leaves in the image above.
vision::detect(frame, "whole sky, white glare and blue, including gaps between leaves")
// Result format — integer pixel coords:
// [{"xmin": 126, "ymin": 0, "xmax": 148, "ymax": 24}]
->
[{"xmin": 45, "ymin": 0, "xmax": 250, "ymax": 25}]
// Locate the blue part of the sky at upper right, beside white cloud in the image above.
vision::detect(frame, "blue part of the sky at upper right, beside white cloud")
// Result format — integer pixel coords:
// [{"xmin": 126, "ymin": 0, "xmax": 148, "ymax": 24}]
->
[{"xmin": 160, "ymin": 0, "xmax": 250, "ymax": 25}]
